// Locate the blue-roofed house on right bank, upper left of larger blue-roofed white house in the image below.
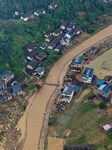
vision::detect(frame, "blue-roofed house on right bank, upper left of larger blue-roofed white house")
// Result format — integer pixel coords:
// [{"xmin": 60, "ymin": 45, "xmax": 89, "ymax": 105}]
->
[{"xmin": 70, "ymin": 56, "xmax": 84, "ymax": 72}]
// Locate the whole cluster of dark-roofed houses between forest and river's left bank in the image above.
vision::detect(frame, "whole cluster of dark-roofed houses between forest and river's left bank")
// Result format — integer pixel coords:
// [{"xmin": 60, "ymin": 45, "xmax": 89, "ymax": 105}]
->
[{"xmin": 22, "ymin": 21, "xmax": 81, "ymax": 76}]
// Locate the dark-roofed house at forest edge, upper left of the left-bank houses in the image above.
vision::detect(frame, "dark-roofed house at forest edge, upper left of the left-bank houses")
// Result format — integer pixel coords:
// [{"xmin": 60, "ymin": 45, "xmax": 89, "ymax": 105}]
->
[{"xmin": 22, "ymin": 42, "xmax": 37, "ymax": 53}]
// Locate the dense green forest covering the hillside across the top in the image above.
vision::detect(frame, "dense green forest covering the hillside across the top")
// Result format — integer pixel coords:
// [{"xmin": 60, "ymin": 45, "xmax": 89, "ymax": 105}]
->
[{"xmin": 0, "ymin": 0, "xmax": 112, "ymax": 75}]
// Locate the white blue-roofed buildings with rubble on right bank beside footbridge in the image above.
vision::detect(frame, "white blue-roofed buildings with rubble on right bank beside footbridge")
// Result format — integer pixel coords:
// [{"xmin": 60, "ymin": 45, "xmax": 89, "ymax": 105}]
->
[{"xmin": 54, "ymin": 75, "xmax": 82, "ymax": 112}]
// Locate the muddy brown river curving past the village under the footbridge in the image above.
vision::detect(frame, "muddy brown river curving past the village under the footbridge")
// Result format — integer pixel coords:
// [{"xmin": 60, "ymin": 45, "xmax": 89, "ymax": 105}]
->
[{"xmin": 18, "ymin": 25, "xmax": 112, "ymax": 150}]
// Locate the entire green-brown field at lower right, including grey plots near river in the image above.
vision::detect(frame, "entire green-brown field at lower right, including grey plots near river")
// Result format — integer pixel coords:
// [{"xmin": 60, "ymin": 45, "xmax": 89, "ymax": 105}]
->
[{"xmin": 49, "ymin": 89, "xmax": 112, "ymax": 150}]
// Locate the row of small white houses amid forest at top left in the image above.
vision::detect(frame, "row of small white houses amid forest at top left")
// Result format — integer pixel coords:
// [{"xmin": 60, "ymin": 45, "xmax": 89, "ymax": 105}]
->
[{"xmin": 13, "ymin": 3, "xmax": 57, "ymax": 22}]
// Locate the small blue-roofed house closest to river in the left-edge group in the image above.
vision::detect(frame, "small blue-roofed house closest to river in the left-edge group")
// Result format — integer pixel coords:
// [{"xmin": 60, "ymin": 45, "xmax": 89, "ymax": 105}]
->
[{"xmin": 11, "ymin": 81, "xmax": 23, "ymax": 96}]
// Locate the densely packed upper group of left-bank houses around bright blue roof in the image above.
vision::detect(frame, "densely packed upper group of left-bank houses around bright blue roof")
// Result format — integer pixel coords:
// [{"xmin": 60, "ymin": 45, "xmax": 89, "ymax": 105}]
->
[{"xmin": 40, "ymin": 20, "xmax": 82, "ymax": 51}]
